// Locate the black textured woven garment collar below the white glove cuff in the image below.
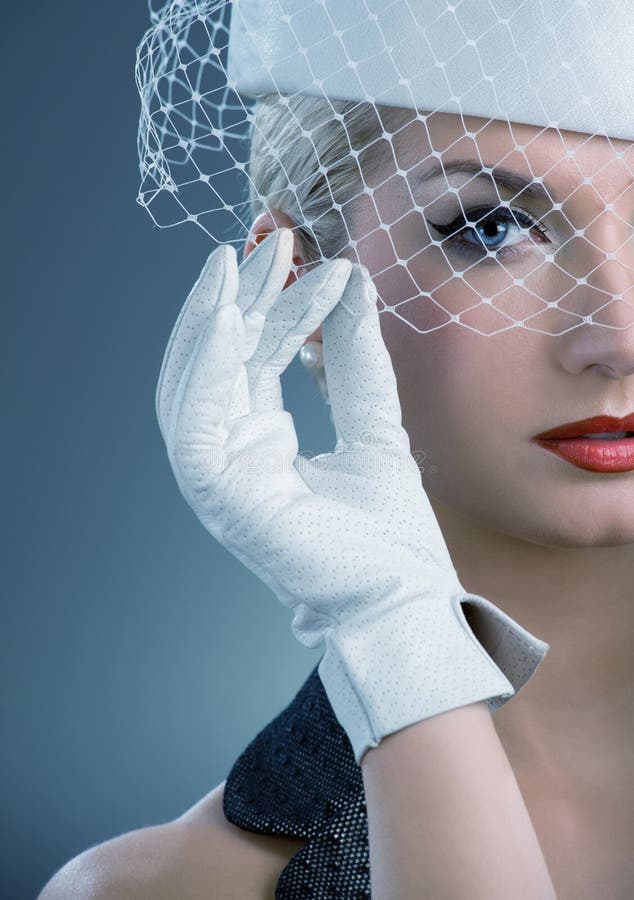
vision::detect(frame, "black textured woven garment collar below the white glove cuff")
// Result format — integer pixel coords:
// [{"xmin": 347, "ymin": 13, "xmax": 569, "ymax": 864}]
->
[{"xmin": 224, "ymin": 667, "xmax": 370, "ymax": 900}]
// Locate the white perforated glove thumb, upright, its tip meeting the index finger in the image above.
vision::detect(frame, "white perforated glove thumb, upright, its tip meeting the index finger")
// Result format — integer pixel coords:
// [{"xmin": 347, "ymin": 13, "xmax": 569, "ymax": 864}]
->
[{"xmin": 323, "ymin": 265, "xmax": 410, "ymax": 453}]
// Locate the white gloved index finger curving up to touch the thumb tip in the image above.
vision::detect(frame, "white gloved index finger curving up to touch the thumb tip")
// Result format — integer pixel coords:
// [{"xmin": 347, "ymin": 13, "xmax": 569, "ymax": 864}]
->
[{"xmin": 245, "ymin": 259, "xmax": 351, "ymax": 412}]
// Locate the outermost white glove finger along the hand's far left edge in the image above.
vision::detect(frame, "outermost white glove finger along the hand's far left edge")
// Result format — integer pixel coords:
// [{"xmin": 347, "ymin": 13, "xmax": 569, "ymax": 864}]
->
[{"xmin": 155, "ymin": 244, "xmax": 238, "ymax": 438}]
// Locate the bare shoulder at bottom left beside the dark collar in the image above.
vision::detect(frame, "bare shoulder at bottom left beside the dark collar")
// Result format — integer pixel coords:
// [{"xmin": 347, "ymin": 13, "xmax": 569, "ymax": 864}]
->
[{"xmin": 38, "ymin": 782, "xmax": 305, "ymax": 900}]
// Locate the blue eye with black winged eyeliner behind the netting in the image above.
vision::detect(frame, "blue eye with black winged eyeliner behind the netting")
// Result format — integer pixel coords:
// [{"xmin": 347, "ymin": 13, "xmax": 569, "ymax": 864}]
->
[{"xmin": 429, "ymin": 206, "xmax": 546, "ymax": 255}]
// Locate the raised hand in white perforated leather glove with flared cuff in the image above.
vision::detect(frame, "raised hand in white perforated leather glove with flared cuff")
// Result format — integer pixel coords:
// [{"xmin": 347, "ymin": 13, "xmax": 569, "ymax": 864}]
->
[{"xmin": 156, "ymin": 229, "xmax": 549, "ymax": 762}]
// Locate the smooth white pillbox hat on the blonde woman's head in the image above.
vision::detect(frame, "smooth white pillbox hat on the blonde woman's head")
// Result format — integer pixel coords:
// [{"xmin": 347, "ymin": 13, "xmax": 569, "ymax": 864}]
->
[{"xmin": 228, "ymin": 0, "xmax": 634, "ymax": 140}]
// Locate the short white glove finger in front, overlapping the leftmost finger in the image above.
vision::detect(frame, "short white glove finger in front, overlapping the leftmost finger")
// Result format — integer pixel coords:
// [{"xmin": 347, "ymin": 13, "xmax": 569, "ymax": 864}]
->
[{"xmin": 170, "ymin": 298, "xmax": 246, "ymax": 484}]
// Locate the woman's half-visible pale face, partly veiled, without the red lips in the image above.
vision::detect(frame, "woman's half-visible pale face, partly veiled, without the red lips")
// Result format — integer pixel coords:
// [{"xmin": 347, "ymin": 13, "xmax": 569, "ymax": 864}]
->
[{"xmin": 346, "ymin": 114, "xmax": 634, "ymax": 547}]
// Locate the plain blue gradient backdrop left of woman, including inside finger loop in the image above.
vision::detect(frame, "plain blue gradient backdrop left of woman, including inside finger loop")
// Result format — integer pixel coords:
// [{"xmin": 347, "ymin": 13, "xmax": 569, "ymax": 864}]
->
[{"xmin": 0, "ymin": 0, "xmax": 334, "ymax": 900}]
